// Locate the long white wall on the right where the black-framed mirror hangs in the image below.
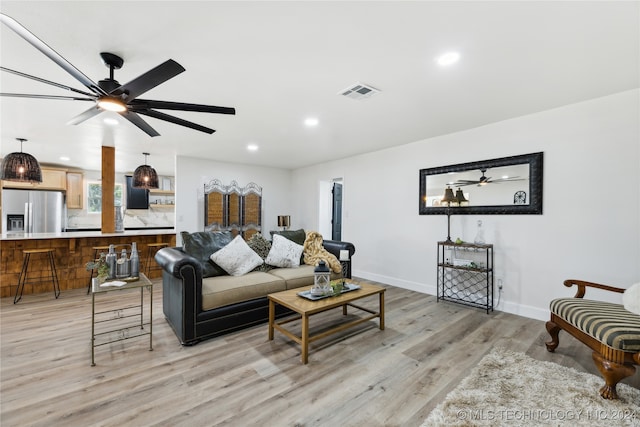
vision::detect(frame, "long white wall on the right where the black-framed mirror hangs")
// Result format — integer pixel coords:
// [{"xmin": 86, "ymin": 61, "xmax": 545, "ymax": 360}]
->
[{"xmin": 291, "ymin": 90, "xmax": 640, "ymax": 319}]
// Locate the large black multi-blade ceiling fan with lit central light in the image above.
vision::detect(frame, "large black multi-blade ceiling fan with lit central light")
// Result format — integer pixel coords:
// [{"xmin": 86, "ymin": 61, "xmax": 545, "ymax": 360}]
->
[{"xmin": 0, "ymin": 14, "xmax": 236, "ymax": 136}]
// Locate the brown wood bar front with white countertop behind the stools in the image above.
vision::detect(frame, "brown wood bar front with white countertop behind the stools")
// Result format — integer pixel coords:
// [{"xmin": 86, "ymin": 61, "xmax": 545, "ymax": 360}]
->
[{"xmin": 0, "ymin": 230, "xmax": 176, "ymax": 297}]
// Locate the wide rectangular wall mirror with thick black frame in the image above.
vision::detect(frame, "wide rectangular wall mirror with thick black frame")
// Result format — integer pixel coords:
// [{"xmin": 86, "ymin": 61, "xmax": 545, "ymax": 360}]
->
[{"xmin": 419, "ymin": 152, "xmax": 543, "ymax": 215}]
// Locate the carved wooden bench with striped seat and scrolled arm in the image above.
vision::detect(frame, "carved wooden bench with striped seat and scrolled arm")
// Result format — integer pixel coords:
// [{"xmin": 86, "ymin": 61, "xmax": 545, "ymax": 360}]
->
[{"xmin": 546, "ymin": 280, "xmax": 640, "ymax": 399}]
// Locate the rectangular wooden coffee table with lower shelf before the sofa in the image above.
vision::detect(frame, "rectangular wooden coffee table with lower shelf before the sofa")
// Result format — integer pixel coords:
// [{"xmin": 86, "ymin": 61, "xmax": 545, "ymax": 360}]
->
[{"xmin": 268, "ymin": 282, "xmax": 386, "ymax": 364}]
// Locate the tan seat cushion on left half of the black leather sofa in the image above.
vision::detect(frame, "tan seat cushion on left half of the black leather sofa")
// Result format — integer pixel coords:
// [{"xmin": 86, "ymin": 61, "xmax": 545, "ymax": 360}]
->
[{"xmin": 202, "ymin": 271, "xmax": 286, "ymax": 311}]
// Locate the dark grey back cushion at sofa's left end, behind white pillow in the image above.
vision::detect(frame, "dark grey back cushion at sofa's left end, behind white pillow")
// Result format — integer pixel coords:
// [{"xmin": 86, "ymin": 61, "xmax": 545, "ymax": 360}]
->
[{"xmin": 180, "ymin": 231, "xmax": 233, "ymax": 277}]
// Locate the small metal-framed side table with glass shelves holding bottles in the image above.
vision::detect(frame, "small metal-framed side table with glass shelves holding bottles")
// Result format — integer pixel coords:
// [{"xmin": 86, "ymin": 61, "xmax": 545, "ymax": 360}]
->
[{"xmin": 91, "ymin": 273, "xmax": 153, "ymax": 366}]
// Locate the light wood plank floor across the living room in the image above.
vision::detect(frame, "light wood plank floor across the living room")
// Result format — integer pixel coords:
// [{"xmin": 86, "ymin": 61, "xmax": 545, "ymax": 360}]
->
[{"xmin": 0, "ymin": 279, "xmax": 640, "ymax": 427}]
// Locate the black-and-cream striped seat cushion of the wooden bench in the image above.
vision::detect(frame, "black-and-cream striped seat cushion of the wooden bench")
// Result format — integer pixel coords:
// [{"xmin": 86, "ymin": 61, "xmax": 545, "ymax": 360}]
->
[{"xmin": 549, "ymin": 298, "xmax": 640, "ymax": 351}]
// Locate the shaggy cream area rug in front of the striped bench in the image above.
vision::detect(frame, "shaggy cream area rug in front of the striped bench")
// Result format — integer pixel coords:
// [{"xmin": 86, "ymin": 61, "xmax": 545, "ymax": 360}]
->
[{"xmin": 422, "ymin": 348, "xmax": 640, "ymax": 427}]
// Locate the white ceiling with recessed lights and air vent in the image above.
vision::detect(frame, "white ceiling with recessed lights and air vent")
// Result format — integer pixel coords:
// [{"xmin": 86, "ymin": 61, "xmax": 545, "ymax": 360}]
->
[{"xmin": 0, "ymin": 0, "xmax": 640, "ymax": 174}]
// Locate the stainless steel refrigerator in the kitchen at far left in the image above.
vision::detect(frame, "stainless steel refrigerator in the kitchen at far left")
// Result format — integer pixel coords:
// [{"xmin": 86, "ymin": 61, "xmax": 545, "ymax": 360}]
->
[{"xmin": 2, "ymin": 190, "xmax": 66, "ymax": 234}]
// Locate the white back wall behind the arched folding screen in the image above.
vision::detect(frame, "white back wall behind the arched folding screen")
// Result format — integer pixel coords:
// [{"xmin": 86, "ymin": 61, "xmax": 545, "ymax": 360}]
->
[{"xmin": 175, "ymin": 156, "xmax": 300, "ymax": 245}]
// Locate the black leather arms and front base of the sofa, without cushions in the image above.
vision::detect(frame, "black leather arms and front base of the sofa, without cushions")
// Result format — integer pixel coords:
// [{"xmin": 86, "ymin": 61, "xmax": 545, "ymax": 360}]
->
[{"xmin": 155, "ymin": 240, "xmax": 355, "ymax": 345}]
